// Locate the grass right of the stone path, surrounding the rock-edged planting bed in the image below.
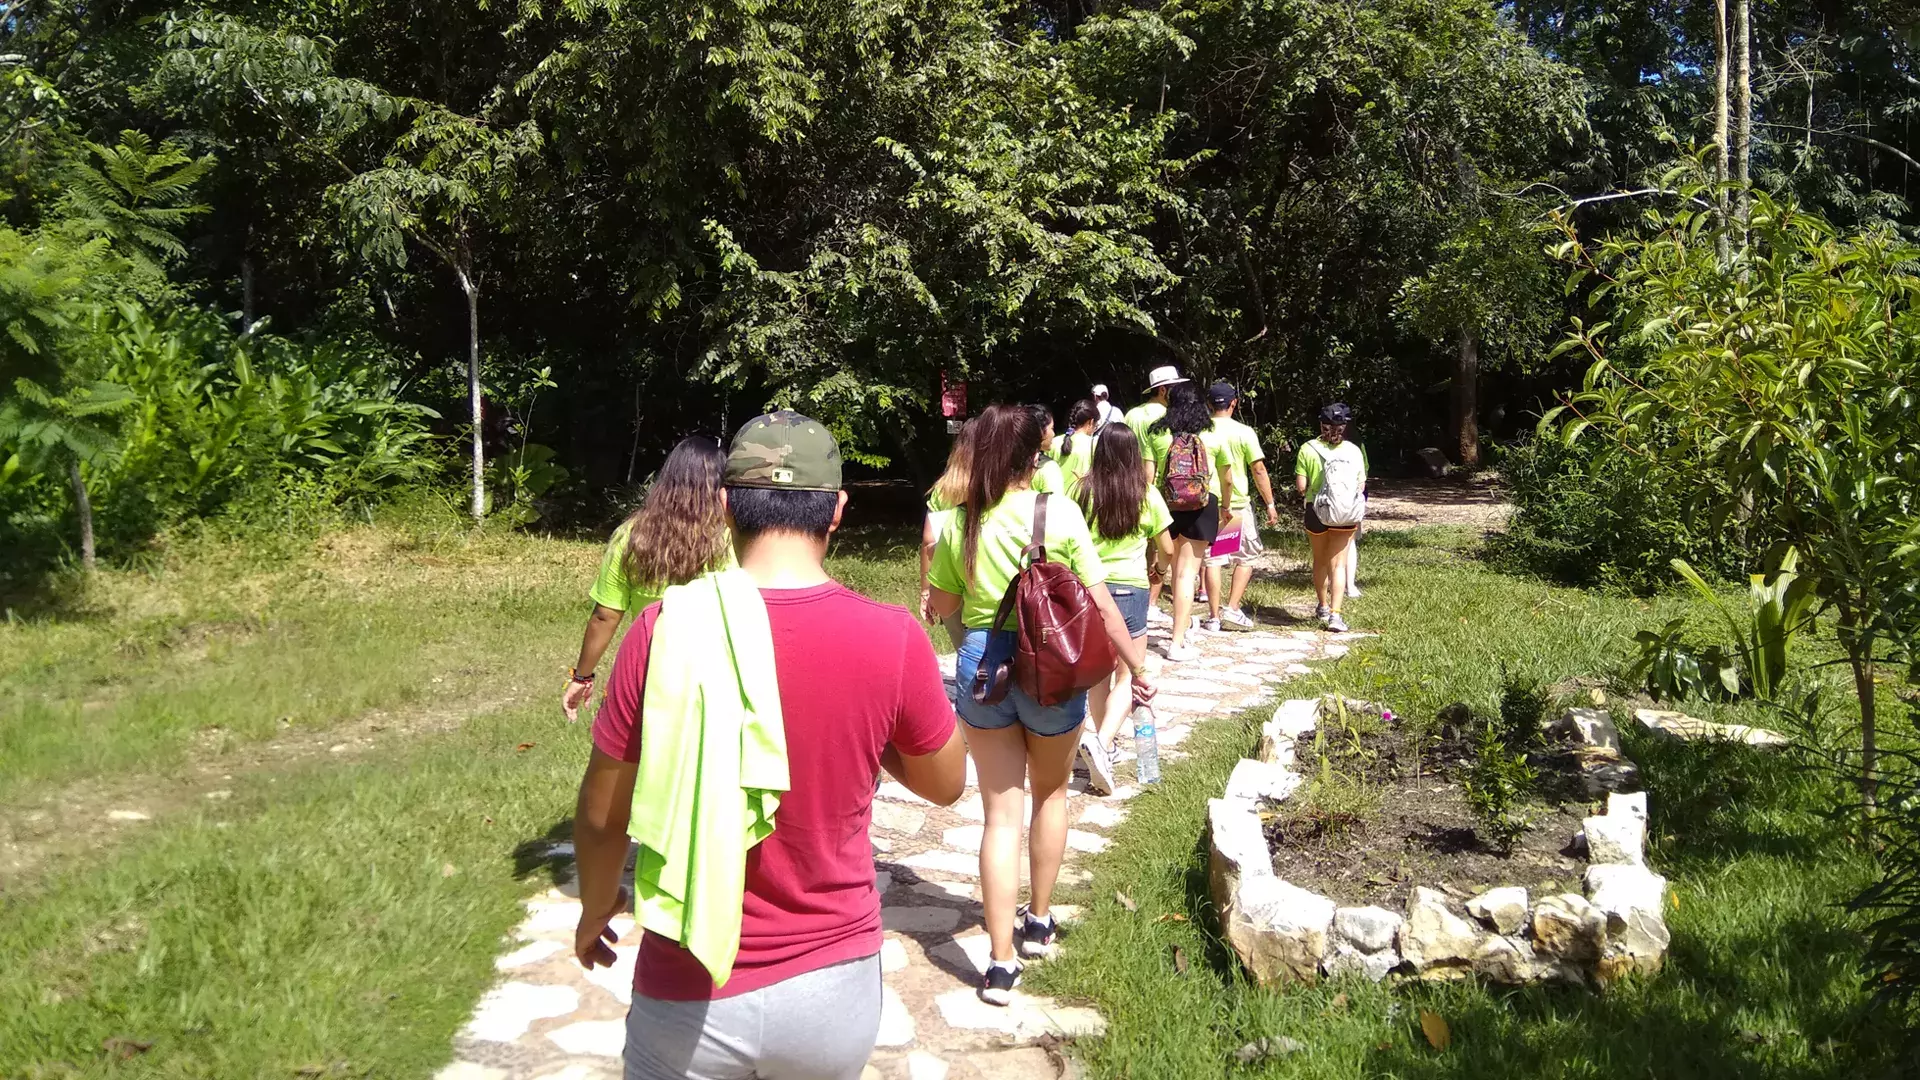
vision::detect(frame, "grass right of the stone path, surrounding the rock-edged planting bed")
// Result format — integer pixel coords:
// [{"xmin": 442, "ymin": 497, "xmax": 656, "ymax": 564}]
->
[{"xmin": 1033, "ymin": 530, "xmax": 1893, "ymax": 1080}]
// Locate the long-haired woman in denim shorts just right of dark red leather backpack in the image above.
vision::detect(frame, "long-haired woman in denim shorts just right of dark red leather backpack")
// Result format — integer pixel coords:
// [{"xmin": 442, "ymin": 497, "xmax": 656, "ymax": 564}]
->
[{"xmin": 1073, "ymin": 425, "xmax": 1173, "ymax": 796}]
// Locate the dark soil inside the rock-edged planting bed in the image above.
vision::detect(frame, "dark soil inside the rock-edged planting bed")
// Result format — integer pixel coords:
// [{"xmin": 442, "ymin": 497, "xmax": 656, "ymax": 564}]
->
[{"xmin": 1267, "ymin": 717, "xmax": 1597, "ymax": 911}]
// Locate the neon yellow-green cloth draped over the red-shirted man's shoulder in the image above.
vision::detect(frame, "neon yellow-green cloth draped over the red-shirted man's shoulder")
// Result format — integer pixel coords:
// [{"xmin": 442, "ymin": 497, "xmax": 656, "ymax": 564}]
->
[{"xmin": 628, "ymin": 571, "xmax": 789, "ymax": 988}]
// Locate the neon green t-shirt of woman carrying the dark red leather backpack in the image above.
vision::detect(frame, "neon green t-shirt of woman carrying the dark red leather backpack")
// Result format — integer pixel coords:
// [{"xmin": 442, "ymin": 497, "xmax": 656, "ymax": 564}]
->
[{"xmin": 927, "ymin": 492, "xmax": 1106, "ymax": 630}]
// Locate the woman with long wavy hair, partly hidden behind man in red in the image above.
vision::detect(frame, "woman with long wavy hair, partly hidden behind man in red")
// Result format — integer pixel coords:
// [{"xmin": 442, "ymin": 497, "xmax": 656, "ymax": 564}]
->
[{"xmin": 561, "ymin": 434, "xmax": 733, "ymax": 723}]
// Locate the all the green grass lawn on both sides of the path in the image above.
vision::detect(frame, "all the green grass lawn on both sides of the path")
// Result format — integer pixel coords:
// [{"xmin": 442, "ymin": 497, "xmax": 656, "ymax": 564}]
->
[{"xmin": 0, "ymin": 511, "xmax": 1885, "ymax": 1080}]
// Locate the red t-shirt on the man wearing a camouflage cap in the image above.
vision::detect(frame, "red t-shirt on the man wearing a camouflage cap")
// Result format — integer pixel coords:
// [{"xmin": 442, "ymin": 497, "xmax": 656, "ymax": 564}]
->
[{"xmin": 593, "ymin": 582, "xmax": 954, "ymax": 1001}]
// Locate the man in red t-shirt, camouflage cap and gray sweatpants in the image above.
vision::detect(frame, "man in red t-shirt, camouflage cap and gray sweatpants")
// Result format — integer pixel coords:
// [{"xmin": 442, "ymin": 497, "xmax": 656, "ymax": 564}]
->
[{"xmin": 574, "ymin": 411, "xmax": 966, "ymax": 1080}]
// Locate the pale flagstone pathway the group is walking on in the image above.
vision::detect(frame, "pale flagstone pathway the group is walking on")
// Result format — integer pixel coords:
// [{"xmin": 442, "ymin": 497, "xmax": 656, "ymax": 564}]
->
[{"xmin": 436, "ymin": 614, "xmax": 1361, "ymax": 1080}]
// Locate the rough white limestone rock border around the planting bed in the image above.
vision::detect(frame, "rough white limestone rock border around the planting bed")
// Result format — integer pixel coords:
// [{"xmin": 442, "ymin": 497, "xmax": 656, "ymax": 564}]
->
[{"xmin": 1208, "ymin": 698, "xmax": 1668, "ymax": 986}]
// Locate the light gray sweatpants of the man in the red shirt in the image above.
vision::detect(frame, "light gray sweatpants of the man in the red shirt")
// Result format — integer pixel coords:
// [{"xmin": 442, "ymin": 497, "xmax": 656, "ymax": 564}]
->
[{"xmin": 626, "ymin": 953, "xmax": 881, "ymax": 1080}]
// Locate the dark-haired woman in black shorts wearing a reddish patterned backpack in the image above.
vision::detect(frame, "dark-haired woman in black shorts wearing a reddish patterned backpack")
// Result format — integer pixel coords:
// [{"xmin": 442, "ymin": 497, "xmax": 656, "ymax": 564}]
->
[{"xmin": 1146, "ymin": 382, "xmax": 1233, "ymax": 663}]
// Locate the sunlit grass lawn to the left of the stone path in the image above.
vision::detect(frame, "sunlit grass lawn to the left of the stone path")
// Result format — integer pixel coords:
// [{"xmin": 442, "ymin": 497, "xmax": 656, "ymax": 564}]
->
[{"xmin": 0, "ymin": 511, "xmax": 916, "ymax": 1080}]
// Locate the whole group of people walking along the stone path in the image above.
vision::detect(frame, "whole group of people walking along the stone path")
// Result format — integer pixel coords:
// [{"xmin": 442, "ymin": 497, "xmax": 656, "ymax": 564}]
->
[{"xmin": 563, "ymin": 367, "xmax": 1365, "ymax": 1078}]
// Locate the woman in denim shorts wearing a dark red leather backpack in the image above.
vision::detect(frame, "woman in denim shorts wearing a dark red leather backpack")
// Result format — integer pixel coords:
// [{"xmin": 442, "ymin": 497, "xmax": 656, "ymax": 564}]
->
[{"xmin": 927, "ymin": 405, "xmax": 1152, "ymax": 1005}]
